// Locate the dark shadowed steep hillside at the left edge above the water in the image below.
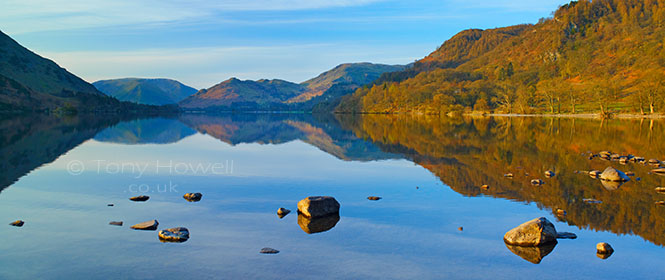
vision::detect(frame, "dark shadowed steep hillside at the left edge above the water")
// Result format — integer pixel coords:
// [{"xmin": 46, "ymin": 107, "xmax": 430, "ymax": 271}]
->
[{"xmin": 0, "ymin": 32, "xmax": 169, "ymax": 112}]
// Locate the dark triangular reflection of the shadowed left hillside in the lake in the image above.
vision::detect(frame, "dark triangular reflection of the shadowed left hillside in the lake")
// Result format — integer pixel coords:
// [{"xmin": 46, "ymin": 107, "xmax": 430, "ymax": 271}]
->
[{"xmin": 0, "ymin": 115, "xmax": 124, "ymax": 190}]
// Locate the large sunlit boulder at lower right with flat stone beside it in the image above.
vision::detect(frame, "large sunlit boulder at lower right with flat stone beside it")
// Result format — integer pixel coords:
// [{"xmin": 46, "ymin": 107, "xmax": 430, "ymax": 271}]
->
[{"xmin": 503, "ymin": 217, "xmax": 557, "ymax": 246}]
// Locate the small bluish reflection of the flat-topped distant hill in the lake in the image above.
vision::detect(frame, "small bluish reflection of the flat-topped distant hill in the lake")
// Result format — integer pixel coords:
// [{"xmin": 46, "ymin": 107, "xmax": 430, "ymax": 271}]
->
[{"xmin": 95, "ymin": 118, "xmax": 196, "ymax": 144}]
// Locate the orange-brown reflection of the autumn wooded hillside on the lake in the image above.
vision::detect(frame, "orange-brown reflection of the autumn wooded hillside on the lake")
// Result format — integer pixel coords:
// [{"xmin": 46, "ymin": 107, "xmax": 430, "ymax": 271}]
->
[{"xmin": 340, "ymin": 115, "xmax": 665, "ymax": 245}]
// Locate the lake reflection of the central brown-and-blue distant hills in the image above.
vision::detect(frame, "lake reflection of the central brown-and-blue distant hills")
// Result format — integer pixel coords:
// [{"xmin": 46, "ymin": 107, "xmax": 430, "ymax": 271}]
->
[{"xmin": 180, "ymin": 114, "xmax": 399, "ymax": 161}]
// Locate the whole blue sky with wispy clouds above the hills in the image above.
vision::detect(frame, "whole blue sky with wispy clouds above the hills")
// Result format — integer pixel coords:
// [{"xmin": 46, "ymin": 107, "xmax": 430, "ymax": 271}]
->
[{"xmin": 0, "ymin": 0, "xmax": 567, "ymax": 89}]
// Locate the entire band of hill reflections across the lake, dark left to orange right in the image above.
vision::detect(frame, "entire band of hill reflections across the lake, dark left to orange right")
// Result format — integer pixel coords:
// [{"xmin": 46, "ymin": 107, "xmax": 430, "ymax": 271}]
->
[{"xmin": 0, "ymin": 114, "xmax": 665, "ymax": 246}]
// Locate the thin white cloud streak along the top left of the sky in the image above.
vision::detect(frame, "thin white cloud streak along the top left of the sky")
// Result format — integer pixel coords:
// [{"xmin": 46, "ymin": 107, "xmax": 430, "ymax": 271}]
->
[{"xmin": 0, "ymin": 0, "xmax": 383, "ymax": 34}]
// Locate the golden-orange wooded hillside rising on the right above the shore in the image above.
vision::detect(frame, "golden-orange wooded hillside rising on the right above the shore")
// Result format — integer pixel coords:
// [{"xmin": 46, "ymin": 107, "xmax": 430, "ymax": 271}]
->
[{"xmin": 336, "ymin": 0, "xmax": 665, "ymax": 115}]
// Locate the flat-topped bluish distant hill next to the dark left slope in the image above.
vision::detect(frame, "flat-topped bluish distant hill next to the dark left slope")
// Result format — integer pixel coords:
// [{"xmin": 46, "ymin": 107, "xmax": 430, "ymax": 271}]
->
[{"xmin": 92, "ymin": 78, "xmax": 197, "ymax": 105}]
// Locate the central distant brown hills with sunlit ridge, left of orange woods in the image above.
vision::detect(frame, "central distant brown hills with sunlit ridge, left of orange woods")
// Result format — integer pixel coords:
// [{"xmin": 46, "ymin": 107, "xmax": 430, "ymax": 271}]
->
[{"xmin": 178, "ymin": 63, "xmax": 405, "ymax": 111}]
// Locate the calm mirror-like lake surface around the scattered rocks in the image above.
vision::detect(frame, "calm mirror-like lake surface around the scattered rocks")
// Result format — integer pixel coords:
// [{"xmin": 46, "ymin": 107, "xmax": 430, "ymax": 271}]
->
[{"xmin": 0, "ymin": 114, "xmax": 665, "ymax": 279}]
